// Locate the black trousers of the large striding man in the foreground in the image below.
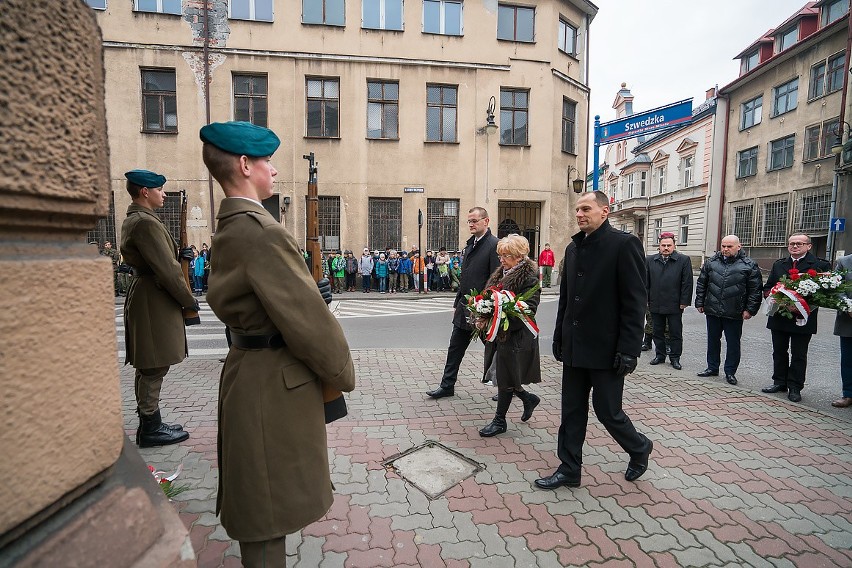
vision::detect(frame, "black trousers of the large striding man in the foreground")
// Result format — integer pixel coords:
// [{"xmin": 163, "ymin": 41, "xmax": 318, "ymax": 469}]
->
[{"xmin": 556, "ymin": 365, "xmax": 648, "ymax": 479}]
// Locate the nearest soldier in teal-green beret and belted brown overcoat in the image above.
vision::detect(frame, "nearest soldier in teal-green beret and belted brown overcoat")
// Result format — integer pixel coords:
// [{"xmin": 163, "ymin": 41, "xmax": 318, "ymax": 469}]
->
[{"xmin": 201, "ymin": 122, "xmax": 355, "ymax": 567}]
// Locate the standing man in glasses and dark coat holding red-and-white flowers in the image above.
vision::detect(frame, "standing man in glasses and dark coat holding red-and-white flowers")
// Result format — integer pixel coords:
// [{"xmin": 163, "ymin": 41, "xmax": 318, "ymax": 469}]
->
[{"xmin": 761, "ymin": 233, "xmax": 831, "ymax": 402}]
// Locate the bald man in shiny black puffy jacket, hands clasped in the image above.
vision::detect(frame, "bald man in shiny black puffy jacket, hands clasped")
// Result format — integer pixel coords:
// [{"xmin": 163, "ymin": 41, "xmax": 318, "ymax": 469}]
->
[{"xmin": 695, "ymin": 235, "xmax": 763, "ymax": 385}]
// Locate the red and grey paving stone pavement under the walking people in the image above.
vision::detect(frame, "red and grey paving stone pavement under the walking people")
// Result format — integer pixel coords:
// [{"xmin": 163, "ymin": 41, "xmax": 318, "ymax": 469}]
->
[{"xmin": 121, "ymin": 350, "xmax": 852, "ymax": 568}]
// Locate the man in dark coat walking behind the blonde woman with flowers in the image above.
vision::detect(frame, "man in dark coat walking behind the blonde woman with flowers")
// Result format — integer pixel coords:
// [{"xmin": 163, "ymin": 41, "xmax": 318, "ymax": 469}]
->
[{"xmin": 426, "ymin": 207, "xmax": 500, "ymax": 398}]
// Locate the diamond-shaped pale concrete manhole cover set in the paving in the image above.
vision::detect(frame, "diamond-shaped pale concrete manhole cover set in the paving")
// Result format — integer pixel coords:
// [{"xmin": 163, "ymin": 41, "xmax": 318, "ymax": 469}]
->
[{"xmin": 382, "ymin": 441, "xmax": 483, "ymax": 499}]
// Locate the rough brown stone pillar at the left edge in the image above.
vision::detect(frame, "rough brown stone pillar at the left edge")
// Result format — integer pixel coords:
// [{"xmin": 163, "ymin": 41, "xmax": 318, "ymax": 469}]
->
[{"xmin": 0, "ymin": 0, "xmax": 195, "ymax": 566}]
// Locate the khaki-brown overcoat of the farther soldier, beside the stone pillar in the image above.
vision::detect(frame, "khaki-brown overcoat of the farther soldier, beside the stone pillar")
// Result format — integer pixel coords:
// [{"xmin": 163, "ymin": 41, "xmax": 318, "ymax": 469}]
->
[{"xmin": 121, "ymin": 204, "xmax": 195, "ymax": 369}]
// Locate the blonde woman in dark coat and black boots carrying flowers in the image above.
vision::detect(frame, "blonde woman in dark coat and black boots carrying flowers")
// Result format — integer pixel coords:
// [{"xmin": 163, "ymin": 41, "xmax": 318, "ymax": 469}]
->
[{"xmin": 477, "ymin": 234, "xmax": 541, "ymax": 437}]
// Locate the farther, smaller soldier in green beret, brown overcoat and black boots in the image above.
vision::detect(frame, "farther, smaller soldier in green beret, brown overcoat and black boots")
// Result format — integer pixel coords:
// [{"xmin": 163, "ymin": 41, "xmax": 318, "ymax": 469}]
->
[{"xmin": 121, "ymin": 170, "xmax": 198, "ymax": 448}]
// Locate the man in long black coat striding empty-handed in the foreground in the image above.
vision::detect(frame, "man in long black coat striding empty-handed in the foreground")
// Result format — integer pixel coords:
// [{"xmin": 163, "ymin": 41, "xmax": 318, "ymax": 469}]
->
[{"xmin": 535, "ymin": 191, "xmax": 654, "ymax": 489}]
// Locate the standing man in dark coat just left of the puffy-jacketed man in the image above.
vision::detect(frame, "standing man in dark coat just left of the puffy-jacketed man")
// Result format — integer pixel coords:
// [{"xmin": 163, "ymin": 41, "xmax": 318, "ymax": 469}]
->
[{"xmin": 647, "ymin": 233, "xmax": 692, "ymax": 370}]
